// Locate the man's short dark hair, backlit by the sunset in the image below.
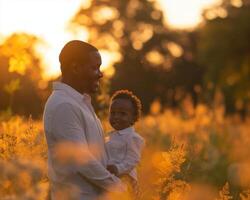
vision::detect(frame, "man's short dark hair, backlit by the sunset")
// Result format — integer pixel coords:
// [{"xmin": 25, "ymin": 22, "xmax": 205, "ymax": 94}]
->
[{"xmin": 59, "ymin": 40, "xmax": 98, "ymax": 71}]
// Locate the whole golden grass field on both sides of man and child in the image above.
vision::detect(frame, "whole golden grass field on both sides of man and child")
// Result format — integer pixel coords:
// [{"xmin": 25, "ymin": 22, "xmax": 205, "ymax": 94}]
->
[{"xmin": 0, "ymin": 101, "xmax": 250, "ymax": 200}]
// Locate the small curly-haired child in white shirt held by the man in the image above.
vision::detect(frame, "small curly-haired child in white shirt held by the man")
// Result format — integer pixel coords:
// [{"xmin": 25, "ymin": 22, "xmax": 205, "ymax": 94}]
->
[{"xmin": 106, "ymin": 90, "xmax": 145, "ymax": 199}]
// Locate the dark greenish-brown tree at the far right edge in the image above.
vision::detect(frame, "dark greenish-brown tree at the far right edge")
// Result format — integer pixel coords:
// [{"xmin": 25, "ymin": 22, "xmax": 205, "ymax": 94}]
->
[{"xmin": 198, "ymin": 0, "xmax": 250, "ymax": 112}]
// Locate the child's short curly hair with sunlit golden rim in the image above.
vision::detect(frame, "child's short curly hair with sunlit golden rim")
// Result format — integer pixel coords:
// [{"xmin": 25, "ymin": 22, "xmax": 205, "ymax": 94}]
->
[{"xmin": 111, "ymin": 90, "xmax": 142, "ymax": 122}]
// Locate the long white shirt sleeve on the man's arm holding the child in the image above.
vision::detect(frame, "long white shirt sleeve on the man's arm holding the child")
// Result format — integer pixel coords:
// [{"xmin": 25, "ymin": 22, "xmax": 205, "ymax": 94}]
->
[{"xmin": 52, "ymin": 103, "xmax": 124, "ymax": 191}]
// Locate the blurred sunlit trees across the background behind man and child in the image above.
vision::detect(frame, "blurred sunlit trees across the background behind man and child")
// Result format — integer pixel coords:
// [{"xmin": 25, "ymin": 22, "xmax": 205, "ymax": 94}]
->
[{"xmin": 0, "ymin": 0, "xmax": 250, "ymax": 116}]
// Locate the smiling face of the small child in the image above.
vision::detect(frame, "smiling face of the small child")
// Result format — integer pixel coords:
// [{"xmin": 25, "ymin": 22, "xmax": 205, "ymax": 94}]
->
[{"xmin": 109, "ymin": 99, "xmax": 135, "ymax": 130}]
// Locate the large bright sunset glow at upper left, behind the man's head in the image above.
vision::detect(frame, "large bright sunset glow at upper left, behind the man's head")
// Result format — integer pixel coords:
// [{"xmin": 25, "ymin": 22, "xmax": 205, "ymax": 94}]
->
[{"xmin": 0, "ymin": 0, "xmax": 87, "ymax": 76}]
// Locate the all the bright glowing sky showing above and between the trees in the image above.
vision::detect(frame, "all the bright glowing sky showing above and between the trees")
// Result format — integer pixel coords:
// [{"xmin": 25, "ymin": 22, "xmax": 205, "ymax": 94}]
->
[{"xmin": 0, "ymin": 0, "xmax": 218, "ymax": 78}]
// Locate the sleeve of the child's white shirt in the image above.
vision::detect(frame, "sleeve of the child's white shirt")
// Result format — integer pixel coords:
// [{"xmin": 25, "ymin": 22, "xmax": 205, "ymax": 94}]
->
[{"xmin": 116, "ymin": 136, "xmax": 145, "ymax": 175}]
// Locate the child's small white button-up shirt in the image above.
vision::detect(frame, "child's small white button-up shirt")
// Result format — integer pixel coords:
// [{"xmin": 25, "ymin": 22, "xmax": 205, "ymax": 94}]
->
[{"xmin": 106, "ymin": 127, "xmax": 145, "ymax": 180}]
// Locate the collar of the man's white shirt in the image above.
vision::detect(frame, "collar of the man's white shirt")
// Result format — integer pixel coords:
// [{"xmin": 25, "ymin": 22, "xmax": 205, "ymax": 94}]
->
[{"xmin": 53, "ymin": 81, "xmax": 91, "ymax": 103}]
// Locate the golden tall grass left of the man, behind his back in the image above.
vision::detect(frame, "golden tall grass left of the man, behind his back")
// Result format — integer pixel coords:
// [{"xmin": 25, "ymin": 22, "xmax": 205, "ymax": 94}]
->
[{"xmin": 0, "ymin": 116, "xmax": 48, "ymax": 200}]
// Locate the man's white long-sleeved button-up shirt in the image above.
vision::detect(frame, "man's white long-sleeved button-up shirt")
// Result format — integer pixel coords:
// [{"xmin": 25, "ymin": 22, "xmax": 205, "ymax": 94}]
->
[{"xmin": 43, "ymin": 82, "xmax": 124, "ymax": 200}]
